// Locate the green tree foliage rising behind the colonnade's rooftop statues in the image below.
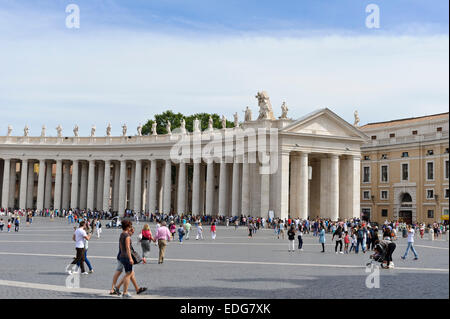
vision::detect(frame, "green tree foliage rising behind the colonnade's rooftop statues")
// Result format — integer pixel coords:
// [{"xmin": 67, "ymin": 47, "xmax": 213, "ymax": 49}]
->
[{"xmin": 142, "ymin": 110, "xmax": 234, "ymax": 135}]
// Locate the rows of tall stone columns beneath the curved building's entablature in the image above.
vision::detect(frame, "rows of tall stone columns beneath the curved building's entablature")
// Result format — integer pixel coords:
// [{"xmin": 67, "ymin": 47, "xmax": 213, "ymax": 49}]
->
[{"xmin": 0, "ymin": 152, "xmax": 360, "ymax": 220}]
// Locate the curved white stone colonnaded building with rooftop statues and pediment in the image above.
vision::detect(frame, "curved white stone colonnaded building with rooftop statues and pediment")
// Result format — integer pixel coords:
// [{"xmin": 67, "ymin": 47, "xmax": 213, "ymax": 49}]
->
[{"xmin": 0, "ymin": 94, "xmax": 367, "ymax": 220}]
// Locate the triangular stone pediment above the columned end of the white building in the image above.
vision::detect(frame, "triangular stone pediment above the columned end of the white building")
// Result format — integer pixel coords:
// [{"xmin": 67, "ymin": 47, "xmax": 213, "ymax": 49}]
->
[{"xmin": 283, "ymin": 109, "xmax": 367, "ymax": 139}]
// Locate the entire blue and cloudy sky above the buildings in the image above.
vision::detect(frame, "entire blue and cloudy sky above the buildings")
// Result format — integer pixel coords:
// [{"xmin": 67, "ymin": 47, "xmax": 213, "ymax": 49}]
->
[{"xmin": 0, "ymin": 0, "xmax": 449, "ymax": 136}]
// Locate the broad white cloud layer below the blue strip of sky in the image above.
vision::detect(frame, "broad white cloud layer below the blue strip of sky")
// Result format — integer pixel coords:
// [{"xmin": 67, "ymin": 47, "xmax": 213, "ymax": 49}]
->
[{"xmin": 0, "ymin": 25, "xmax": 449, "ymax": 135}]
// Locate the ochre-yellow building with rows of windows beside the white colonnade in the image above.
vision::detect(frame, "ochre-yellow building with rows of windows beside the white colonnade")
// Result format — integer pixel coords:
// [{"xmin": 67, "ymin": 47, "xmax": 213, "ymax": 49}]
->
[{"xmin": 360, "ymin": 113, "xmax": 449, "ymax": 224}]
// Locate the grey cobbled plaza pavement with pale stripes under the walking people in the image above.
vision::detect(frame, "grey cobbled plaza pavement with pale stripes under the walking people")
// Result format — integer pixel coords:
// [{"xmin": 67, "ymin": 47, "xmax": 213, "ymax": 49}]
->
[{"xmin": 0, "ymin": 216, "xmax": 449, "ymax": 299}]
